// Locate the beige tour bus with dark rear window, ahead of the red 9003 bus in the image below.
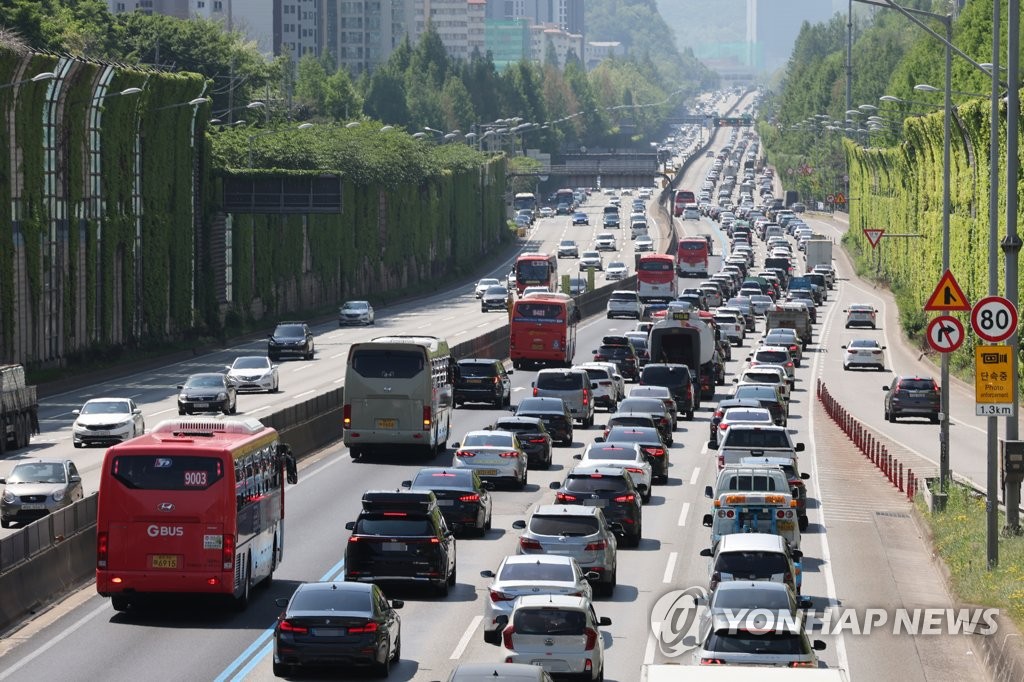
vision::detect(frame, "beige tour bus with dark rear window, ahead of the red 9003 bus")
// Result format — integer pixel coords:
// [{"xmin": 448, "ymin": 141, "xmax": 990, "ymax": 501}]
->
[{"xmin": 342, "ymin": 336, "xmax": 455, "ymax": 458}]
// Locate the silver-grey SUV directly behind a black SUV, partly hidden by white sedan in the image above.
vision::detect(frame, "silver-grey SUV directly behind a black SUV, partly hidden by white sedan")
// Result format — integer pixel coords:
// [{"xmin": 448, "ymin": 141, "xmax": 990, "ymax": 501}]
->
[{"xmin": 512, "ymin": 505, "xmax": 622, "ymax": 596}]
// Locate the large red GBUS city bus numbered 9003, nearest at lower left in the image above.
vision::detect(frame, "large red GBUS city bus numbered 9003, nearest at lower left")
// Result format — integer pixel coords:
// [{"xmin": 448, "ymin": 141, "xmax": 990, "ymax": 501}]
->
[{"xmin": 96, "ymin": 418, "xmax": 297, "ymax": 611}]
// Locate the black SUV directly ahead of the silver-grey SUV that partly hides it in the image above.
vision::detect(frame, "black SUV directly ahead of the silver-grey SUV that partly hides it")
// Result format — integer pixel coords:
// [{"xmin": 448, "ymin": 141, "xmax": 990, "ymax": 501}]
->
[{"xmin": 549, "ymin": 464, "xmax": 643, "ymax": 547}]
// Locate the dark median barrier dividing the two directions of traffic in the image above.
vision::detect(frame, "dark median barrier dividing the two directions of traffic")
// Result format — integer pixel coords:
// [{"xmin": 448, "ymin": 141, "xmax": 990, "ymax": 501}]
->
[{"xmin": 0, "ymin": 278, "xmax": 636, "ymax": 632}]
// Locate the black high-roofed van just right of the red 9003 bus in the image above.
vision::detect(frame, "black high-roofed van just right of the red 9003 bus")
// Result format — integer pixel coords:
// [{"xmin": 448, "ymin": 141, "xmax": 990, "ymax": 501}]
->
[{"xmin": 345, "ymin": 491, "xmax": 456, "ymax": 597}]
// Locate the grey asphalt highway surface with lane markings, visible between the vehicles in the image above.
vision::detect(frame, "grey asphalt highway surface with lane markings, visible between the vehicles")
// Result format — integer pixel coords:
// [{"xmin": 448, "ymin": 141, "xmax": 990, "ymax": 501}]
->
[{"xmin": 0, "ymin": 91, "xmax": 983, "ymax": 682}]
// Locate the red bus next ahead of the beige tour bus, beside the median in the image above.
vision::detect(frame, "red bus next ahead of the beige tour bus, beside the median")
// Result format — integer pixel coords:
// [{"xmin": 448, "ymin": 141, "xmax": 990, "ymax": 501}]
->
[{"xmin": 509, "ymin": 294, "xmax": 579, "ymax": 370}]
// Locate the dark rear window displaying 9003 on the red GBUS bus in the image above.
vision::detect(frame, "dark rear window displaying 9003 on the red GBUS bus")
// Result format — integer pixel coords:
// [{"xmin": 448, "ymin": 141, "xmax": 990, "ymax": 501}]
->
[{"xmin": 111, "ymin": 455, "xmax": 224, "ymax": 491}]
